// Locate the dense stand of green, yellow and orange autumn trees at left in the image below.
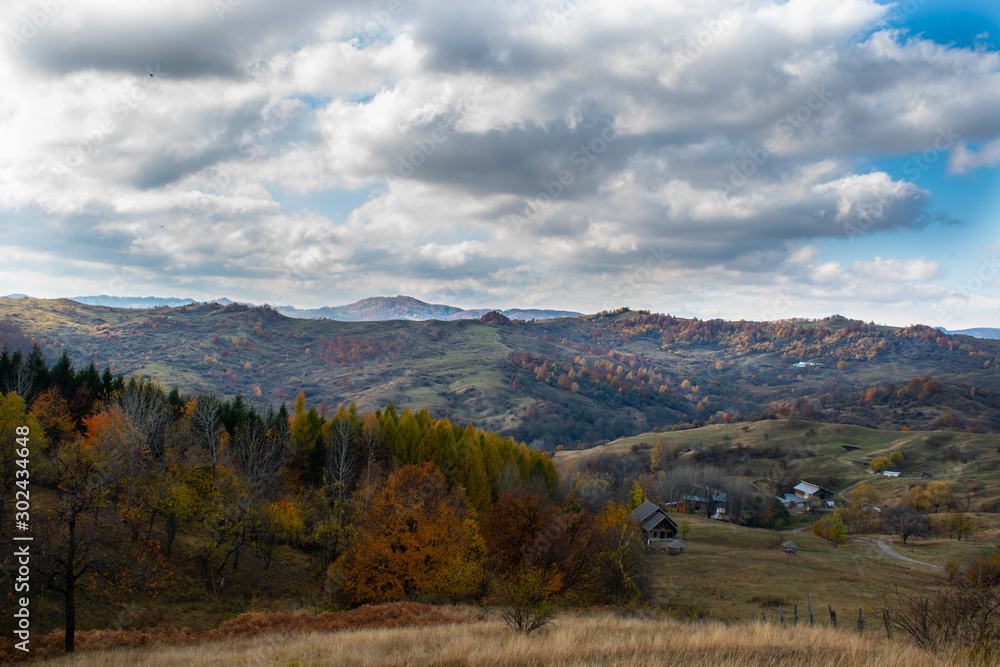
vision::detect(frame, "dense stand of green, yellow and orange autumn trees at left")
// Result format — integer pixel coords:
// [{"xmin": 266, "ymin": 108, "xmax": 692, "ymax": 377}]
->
[{"xmin": 0, "ymin": 354, "xmax": 645, "ymax": 651}]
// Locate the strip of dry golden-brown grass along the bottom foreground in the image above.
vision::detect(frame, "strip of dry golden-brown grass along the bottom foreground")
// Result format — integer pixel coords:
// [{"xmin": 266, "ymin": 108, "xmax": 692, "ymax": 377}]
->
[{"xmin": 31, "ymin": 612, "xmax": 984, "ymax": 667}]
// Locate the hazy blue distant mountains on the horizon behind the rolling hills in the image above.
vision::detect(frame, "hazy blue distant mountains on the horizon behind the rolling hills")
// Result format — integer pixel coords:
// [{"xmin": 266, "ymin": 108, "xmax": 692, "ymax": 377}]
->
[{"xmin": 5, "ymin": 294, "xmax": 581, "ymax": 322}]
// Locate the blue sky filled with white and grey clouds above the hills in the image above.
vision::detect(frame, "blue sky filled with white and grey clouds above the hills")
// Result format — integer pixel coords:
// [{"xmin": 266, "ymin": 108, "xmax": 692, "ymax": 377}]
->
[{"xmin": 0, "ymin": 0, "xmax": 1000, "ymax": 329}]
